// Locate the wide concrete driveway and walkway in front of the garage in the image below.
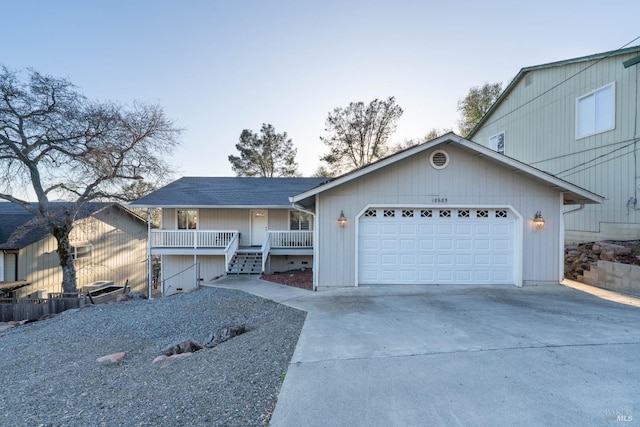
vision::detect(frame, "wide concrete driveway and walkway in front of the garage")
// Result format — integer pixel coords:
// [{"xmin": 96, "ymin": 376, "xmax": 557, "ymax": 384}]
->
[{"xmin": 212, "ymin": 279, "xmax": 640, "ymax": 427}]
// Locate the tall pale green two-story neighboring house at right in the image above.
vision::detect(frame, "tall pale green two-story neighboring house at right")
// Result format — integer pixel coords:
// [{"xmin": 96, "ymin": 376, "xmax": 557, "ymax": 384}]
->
[{"xmin": 467, "ymin": 46, "xmax": 640, "ymax": 242}]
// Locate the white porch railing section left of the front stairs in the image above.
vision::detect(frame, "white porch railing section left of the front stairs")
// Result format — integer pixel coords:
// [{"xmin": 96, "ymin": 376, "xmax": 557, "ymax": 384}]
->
[{"xmin": 151, "ymin": 230, "xmax": 238, "ymax": 248}]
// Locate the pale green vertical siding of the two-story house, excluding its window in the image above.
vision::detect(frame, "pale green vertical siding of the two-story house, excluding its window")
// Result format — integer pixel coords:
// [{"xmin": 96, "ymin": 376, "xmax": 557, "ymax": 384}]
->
[{"xmin": 472, "ymin": 54, "xmax": 640, "ymax": 240}]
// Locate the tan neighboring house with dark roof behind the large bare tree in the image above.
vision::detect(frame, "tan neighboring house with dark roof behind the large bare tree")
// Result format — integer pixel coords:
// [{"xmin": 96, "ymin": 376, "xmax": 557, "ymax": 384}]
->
[{"xmin": 0, "ymin": 202, "xmax": 148, "ymax": 298}]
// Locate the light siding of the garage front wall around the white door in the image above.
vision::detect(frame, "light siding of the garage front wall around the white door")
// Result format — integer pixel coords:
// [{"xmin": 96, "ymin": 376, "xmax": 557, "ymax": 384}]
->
[{"xmin": 316, "ymin": 146, "xmax": 561, "ymax": 286}]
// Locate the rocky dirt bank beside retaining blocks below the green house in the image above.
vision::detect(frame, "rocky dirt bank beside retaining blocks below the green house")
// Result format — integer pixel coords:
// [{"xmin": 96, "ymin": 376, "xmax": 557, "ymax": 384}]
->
[{"xmin": 564, "ymin": 240, "xmax": 640, "ymax": 280}]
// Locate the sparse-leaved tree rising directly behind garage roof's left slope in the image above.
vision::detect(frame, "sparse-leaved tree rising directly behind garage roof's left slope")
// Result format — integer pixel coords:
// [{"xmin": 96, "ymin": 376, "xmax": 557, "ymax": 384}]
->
[{"xmin": 320, "ymin": 96, "xmax": 403, "ymax": 175}]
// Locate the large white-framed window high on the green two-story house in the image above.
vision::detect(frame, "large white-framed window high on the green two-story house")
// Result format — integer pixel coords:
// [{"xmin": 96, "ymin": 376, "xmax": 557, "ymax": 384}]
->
[{"xmin": 576, "ymin": 82, "xmax": 616, "ymax": 139}]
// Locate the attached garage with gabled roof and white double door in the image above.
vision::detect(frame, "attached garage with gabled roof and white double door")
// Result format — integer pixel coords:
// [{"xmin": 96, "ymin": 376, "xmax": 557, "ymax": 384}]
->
[{"xmin": 291, "ymin": 133, "xmax": 604, "ymax": 288}]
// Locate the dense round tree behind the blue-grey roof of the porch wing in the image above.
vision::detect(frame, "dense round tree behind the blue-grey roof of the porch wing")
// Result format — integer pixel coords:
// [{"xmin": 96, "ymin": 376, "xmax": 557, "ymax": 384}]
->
[{"xmin": 229, "ymin": 124, "xmax": 299, "ymax": 178}]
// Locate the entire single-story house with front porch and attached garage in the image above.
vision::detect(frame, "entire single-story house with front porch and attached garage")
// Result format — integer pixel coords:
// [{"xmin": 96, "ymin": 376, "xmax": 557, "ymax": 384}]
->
[{"xmin": 131, "ymin": 133, "xmax": 604, "ymax": 293}]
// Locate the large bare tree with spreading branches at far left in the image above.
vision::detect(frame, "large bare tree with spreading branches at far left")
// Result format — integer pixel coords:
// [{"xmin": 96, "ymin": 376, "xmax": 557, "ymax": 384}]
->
[{"xmin": 0, "ymin": 66, "xmax": 180, "ymax": 292}]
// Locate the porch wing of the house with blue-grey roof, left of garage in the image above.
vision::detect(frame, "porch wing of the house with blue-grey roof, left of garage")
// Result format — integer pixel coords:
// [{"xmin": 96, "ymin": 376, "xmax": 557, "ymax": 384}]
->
[{"xmin": 129, "ymin": 177, "xmax": 327, "ymax": 295}]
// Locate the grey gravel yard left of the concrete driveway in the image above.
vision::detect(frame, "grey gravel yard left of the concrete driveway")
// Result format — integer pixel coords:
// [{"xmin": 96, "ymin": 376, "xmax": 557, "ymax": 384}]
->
[{"xmin": 0, "ymin": 288, "xmax": 306, "ymax": 426}]
